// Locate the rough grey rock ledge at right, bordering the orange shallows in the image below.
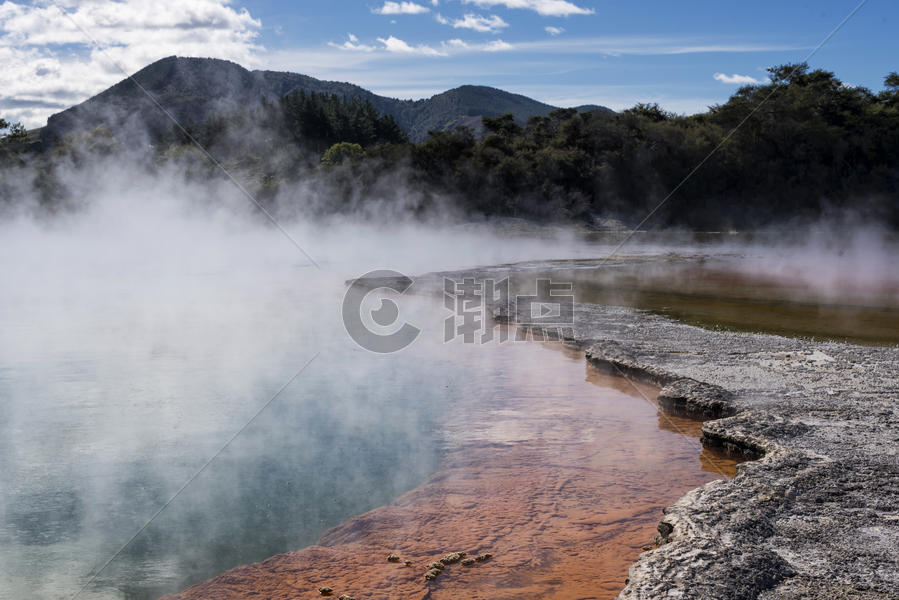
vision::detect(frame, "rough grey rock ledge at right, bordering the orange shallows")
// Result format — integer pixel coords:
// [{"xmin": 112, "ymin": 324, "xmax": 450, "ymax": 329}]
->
[{"xmin": 556, "ymin": 305, "xmax": 899, "ymax": 600}]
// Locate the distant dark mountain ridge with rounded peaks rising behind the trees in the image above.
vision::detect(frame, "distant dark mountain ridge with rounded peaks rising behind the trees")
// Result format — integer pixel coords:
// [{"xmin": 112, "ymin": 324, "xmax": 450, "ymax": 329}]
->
[{"xmin": 40, "ymin": 56, "xmax": 609, "ymax": 147}]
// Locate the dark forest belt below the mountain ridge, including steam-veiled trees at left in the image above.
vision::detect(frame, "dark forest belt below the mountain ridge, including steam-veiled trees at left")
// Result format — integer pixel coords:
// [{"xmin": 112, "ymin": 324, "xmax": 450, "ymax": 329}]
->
[{"xmin": 4, "ymin": 64, "xmax": 899, "ymax": 229}]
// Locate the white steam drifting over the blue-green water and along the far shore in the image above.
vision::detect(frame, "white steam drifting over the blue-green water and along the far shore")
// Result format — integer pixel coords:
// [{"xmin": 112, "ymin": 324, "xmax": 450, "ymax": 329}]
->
[{"xmin": 0, "ymin": 166, "xmax": 895, "ymax": 600}]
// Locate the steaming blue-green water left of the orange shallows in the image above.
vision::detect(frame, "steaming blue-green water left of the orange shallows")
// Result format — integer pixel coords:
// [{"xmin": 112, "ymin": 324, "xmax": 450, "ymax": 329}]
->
[{"xmin": 0, "ymin": 274, "xmax": 442, "ymax": 598}]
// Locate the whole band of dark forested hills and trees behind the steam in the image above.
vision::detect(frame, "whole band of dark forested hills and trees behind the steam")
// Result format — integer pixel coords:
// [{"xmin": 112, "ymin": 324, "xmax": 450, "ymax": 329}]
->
[{"xmin": 0, "ymin": 59, "xmax": 899, "ymax": 231}]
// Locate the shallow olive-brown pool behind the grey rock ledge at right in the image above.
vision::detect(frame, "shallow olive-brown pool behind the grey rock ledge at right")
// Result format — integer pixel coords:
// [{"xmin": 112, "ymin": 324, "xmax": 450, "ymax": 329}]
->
[{"xmin": 512, "ymin": 256, "xmax": 899, "ymax": 345}]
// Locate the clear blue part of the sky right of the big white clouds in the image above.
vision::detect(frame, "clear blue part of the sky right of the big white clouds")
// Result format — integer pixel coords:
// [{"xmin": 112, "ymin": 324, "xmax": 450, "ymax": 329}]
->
[{"xmin": 241, "ymin": 0, "xmax": 899, "ymax": 112}]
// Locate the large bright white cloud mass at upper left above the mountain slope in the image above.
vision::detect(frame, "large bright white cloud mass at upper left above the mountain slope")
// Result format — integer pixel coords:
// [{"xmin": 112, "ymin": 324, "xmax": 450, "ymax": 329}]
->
[{"xmin": 0, "ymin": 0, "xmax": 261, "ymax": 127}]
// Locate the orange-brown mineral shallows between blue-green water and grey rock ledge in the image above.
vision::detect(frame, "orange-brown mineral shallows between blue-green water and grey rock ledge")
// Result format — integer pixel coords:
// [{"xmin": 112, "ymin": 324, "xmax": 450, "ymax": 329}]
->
[{"xmin": 162, "ymin": 345, "xmax": 735, "ymax": 600}]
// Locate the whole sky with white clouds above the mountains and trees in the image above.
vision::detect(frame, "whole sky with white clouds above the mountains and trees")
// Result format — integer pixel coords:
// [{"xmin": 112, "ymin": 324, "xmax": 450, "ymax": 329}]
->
[{"xmin": 0, "ymin": 0, "xmax": 899, "ymax": 127}]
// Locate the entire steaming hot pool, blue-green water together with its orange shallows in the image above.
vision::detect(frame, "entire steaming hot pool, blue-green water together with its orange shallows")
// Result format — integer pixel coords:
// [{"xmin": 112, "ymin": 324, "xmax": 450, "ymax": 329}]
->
[{"xmin": 0, "ymin": 216, "xmax": 895, "ymax": 600}]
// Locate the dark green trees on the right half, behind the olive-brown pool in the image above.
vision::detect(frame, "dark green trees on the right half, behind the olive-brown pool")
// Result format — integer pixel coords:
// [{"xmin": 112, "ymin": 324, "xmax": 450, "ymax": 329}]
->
[{"xmin": 370, "ymin": 64, "xmax": 899, "ymax": 229}]
